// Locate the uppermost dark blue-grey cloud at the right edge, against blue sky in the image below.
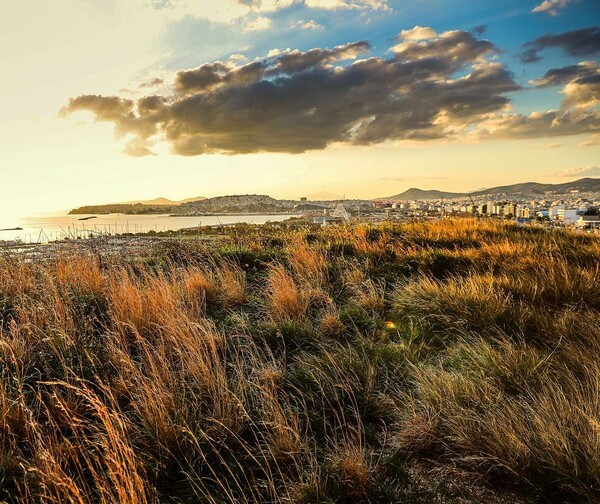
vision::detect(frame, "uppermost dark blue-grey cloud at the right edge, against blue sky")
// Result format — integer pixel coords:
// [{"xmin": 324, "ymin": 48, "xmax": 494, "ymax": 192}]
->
[{"xmin": 521, "ymin": 26, "xmax": 600, "ymax": 63}]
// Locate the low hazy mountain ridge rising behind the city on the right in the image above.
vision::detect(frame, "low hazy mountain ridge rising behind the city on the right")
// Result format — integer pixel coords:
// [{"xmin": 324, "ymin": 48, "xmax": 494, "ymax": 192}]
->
[{"xmin": 378, "ymin": 178, "xmax": 600, "ymax": 201}]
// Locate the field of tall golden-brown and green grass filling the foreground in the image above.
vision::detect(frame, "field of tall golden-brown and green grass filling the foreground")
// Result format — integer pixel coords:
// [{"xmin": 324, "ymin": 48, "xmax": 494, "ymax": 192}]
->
[{"xmin": 0, "ymin": 219, "xmax": 600, "ymax": 504}]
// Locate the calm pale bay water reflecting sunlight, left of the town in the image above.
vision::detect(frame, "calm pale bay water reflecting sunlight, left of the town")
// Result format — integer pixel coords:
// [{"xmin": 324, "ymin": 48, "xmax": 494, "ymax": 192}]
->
[{"xmin": 0, "ymin": 214, "xmax": 292, "ymax": 243}]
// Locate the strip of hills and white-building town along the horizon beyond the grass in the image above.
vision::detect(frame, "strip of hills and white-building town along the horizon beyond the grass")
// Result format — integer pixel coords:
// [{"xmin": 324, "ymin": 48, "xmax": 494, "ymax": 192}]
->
[{"xmin": 70, "ymin": 178, "xmax": 600, "ymax": 231}]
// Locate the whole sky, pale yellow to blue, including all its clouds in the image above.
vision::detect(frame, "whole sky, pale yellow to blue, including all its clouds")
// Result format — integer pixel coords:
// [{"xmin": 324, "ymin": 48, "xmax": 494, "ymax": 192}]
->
[{"xmin": 0, "ymin": 0, "xmax": 600, "ymax": 223}]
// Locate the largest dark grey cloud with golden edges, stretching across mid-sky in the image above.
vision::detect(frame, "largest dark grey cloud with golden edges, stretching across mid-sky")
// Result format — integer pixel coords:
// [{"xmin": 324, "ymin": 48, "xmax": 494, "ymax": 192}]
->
[{"xmin": 63, "ymin": 29, "xmax": 593, "ymax": 156}]
